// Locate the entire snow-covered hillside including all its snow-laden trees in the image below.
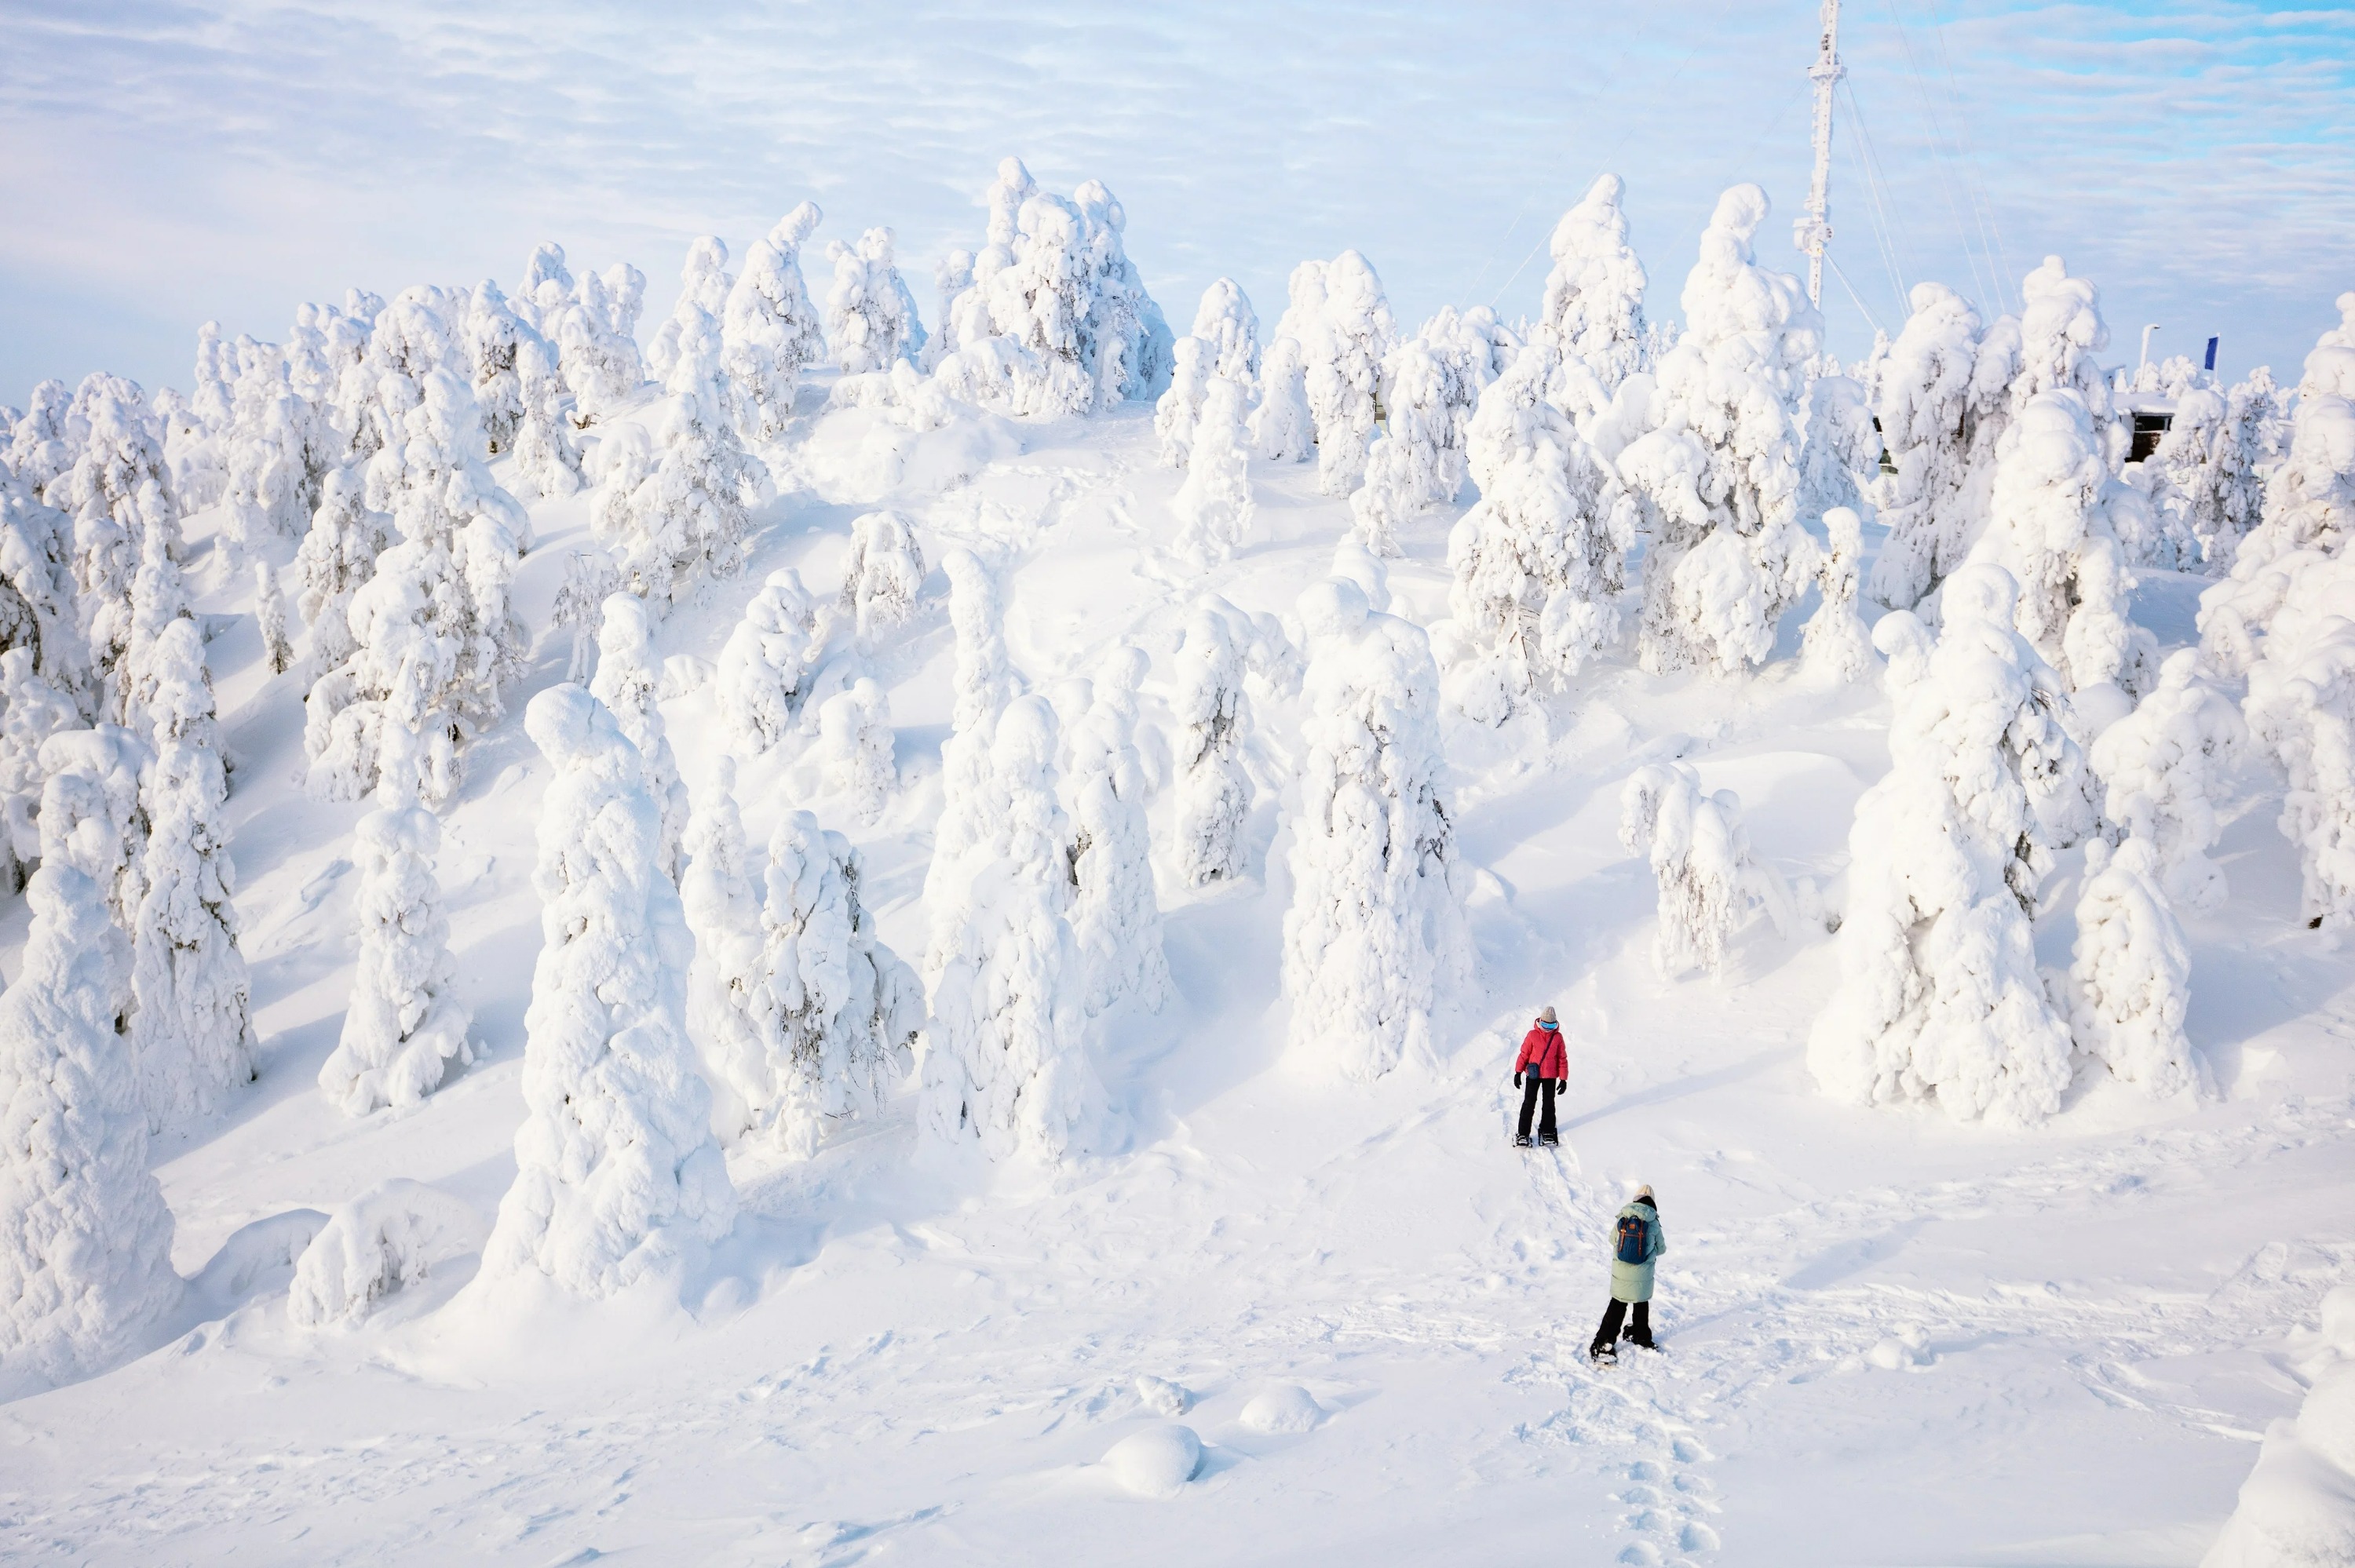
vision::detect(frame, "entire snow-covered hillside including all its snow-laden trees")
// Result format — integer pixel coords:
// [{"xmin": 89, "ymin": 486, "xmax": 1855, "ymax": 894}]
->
[{"xmin": 0, "ymin": 160, "xmax": 2355, "ymax": 1566}]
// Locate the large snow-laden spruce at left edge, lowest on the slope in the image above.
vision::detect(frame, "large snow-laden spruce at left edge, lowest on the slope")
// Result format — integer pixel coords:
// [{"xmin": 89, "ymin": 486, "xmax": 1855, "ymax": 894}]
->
[{"xmin": 0, "ymin": 859, "xmax": 181, "ymax": 1396}]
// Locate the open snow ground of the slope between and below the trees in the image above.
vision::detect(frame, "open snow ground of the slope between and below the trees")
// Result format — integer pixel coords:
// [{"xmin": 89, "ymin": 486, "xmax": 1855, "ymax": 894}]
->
[{"xmin": 0, "ymin": 379, "xmax": 2355, "ymax": 1566}]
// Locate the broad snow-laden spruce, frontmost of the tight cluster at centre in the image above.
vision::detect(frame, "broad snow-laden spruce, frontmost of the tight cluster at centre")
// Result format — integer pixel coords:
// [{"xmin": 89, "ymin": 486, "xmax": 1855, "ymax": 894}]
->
[{"xmin": 918, "ymin": 692, "xmax": 1107, "ymax": 1161}]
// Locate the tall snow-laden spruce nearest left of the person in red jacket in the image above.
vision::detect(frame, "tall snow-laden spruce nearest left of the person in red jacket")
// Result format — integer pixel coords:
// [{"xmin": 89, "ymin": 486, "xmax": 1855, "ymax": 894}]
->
[{"xmin": 1283, "ymin": 579, "xmax": 1472, "ymax": 1081}]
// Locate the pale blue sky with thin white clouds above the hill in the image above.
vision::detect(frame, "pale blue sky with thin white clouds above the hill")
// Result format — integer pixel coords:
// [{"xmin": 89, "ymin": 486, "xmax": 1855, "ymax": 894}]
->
[{"xmin": 0, "ymin": 0, "xmax": 2355, "ymax": 403}]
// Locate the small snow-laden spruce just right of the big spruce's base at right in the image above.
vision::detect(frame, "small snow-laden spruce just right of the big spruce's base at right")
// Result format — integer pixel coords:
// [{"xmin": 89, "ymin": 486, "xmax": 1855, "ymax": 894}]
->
[{"xmin": 2068, "ymin": 838, "xmax": 2200, "ymax": 1099}]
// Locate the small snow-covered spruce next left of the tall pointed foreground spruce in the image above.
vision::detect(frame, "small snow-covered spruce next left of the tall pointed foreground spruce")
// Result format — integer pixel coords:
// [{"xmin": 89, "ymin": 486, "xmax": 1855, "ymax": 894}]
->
[{"xmin": 318, "ymin": 786, "xmax": 473, "ymax": 1116}]
